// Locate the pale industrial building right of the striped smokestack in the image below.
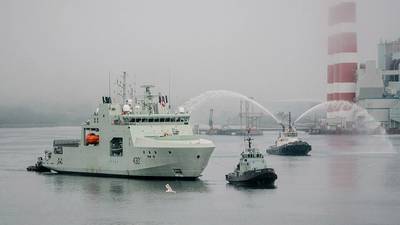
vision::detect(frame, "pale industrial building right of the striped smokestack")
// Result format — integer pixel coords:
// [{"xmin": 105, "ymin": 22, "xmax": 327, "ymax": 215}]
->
[{"xmin": 356, "ymin": 39, "xmax": 400, "ymax": 133}]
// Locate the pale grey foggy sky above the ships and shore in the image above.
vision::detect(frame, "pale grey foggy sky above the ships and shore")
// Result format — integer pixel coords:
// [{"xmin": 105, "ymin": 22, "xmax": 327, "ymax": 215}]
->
[{"xmin": 0, "ymin": 0, "xmax": 400, "ymax": 109}]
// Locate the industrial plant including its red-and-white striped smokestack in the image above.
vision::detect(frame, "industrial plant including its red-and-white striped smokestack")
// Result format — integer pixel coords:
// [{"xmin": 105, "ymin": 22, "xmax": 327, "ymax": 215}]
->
[{"xmin": 314, "ymin": 0, "xmax": 400, "ymax": 133}]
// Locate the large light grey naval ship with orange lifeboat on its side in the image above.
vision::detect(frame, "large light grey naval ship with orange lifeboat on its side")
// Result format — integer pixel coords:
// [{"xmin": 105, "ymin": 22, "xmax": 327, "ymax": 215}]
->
[{"xmin": 28, "ymin": 76, "xmax": 215, "ymax": 179}]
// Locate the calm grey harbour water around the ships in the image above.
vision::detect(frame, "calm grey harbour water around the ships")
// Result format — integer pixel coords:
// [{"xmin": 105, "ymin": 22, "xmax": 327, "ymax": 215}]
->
[{"xmin": 0, "ymin": 127, "xmax": 400, "ymax": 225}]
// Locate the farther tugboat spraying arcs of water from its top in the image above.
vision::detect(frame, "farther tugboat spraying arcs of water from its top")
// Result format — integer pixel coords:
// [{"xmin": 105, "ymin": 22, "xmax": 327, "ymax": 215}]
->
[{"xmin": 266, "ymin": 112, "xmax": 311, "ymax": 156}]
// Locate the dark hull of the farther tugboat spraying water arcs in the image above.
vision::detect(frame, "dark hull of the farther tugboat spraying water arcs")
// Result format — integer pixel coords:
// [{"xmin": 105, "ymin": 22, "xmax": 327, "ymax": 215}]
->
[{"xmin": 266, "ymin": 141, "xmax": 311, "ymax": 156}]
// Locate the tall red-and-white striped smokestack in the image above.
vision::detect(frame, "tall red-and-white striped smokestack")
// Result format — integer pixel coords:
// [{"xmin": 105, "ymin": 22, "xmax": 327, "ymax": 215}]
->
[{"xmin": 327, "ymin": 0, "xmax": 358, "ymax": 117}]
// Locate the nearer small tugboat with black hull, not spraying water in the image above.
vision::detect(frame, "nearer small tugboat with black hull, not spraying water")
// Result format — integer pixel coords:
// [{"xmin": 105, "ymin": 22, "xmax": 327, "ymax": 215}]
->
[{"xmin": 225, "ymin": 133, "xmax": 278, "ymax": 188}]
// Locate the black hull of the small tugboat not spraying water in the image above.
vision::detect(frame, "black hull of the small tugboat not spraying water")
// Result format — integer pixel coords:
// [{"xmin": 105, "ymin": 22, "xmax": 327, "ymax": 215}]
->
[{"xmin": 225, "ymin": 168, "xmax": 278, "ymax": 187}]
